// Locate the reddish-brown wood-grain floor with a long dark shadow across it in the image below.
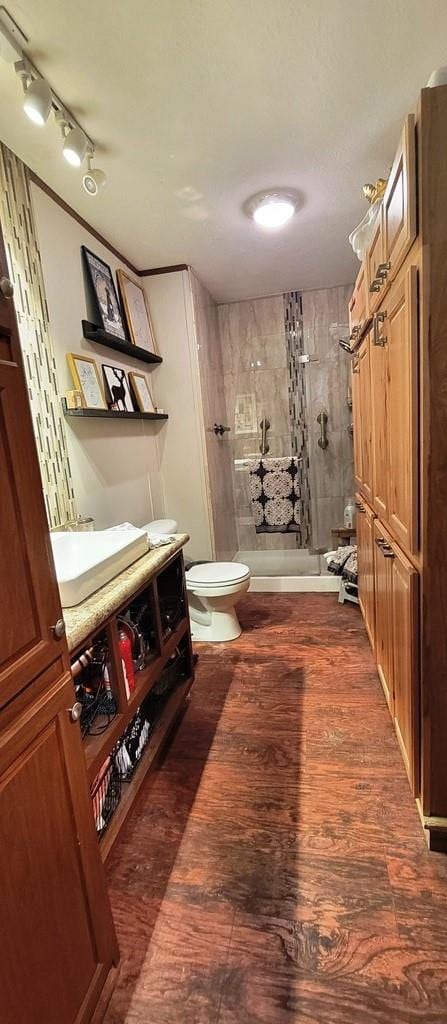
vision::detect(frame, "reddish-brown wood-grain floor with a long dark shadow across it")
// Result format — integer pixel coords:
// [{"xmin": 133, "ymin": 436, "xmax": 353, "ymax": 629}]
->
[{"xmin": 102, "ymin": 594, "xmax": 447, "ymax": 1024}]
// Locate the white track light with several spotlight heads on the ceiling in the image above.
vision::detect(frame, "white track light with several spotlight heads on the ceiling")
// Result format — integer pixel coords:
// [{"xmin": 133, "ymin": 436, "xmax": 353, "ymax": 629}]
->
[{"xmin": 0, "ymin": 6, "xmax": 105, "ymax": 196}]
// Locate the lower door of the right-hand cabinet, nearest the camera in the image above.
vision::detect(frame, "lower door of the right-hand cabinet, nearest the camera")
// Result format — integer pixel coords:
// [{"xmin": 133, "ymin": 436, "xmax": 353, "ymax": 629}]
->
[{"xmin": 393, "ymin": 544, "xmax": 420, "ymax": 797}]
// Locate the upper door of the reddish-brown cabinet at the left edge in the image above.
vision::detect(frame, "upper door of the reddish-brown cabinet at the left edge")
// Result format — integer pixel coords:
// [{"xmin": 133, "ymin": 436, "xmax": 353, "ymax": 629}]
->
[{"xmin": 0, "ymin": 220, "xmax": 68, "ymax": 707}]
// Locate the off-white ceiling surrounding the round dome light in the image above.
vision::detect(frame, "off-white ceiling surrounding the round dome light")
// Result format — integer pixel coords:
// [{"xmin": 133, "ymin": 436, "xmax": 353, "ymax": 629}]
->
[{"xmin": 0, "ymin": 0, "xmax": 447, "ymax": 301}]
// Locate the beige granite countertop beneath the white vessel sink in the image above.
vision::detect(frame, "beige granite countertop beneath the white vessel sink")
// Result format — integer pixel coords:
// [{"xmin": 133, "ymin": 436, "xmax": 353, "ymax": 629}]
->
[{"xmin": 63, "ymin": 534, "xmax": 189, "ymax": 651}]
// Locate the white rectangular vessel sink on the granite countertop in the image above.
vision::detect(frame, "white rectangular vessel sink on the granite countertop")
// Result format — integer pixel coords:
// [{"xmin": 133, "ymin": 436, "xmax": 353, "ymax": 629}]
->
[{"xmin": 51, "ymin": 529, "xmax": 148, "ymax": 608}]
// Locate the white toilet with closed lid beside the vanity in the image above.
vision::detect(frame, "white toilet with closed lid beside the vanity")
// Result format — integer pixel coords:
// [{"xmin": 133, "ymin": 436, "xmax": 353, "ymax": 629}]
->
[{"xmin": 142, "ymin": 519, "xmax": 250, "ymax": 643}]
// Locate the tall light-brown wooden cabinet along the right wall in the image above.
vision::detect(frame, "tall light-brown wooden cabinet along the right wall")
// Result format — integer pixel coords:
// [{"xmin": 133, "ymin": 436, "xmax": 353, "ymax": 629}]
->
[{"xmin": 352, "ymin": 79, "xmax": 447, "ymax": 849}]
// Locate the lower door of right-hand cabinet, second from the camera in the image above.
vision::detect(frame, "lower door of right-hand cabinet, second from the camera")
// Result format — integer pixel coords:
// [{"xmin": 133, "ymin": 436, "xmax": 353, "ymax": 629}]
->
[{"xmin": 373, "ymin": 520, "xmax": 394, "ymax": 718}]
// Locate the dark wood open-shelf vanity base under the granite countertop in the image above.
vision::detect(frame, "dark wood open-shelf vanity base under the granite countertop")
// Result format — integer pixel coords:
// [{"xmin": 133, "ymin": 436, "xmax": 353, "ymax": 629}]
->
[{"xmin": 72, "ymin": 552, "xmax": 193, "ymax": 859}]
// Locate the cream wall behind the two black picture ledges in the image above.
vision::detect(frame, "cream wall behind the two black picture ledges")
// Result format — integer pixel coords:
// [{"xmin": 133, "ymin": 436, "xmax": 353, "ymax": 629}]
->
[{"xmin": 32, "ymin": 184, "xmax": 163, "ymax": 529}]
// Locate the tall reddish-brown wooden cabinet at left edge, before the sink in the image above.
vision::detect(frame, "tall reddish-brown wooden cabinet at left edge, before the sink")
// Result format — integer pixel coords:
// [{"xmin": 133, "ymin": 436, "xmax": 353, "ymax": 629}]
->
[{"xmin": 0, "ymin": 220, "xmax": 118, "ymax": 1024}]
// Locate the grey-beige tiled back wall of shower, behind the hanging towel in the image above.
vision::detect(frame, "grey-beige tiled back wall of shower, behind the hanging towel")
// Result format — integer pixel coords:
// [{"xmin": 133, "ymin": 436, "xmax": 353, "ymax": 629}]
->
[{"xmin": 219, "ymin": 286, "xmax": 353, "ymax": 551}]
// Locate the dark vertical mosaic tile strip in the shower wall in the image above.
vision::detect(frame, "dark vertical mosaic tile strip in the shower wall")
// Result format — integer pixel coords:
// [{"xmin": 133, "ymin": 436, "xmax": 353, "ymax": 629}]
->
[{"xmin": 284, "ymin": 292, "xmax": 312, "ymax": 548}]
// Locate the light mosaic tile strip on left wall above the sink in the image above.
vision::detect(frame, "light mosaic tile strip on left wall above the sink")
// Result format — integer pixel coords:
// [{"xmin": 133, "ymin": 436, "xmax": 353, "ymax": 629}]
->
[{"xmin": 0, "ymin": 144, "xmax": 76, "ymax": 528}]
